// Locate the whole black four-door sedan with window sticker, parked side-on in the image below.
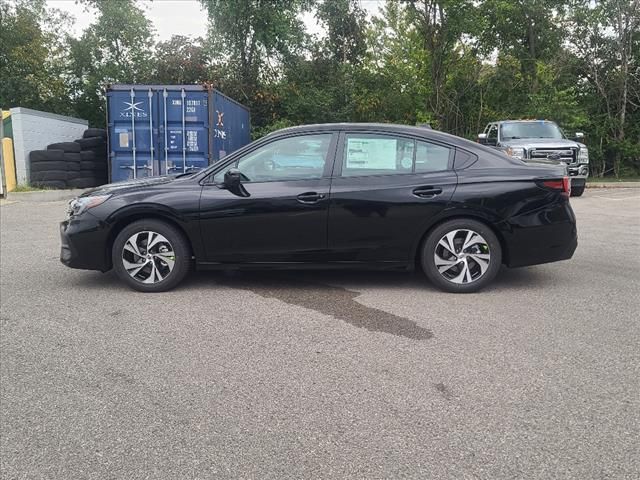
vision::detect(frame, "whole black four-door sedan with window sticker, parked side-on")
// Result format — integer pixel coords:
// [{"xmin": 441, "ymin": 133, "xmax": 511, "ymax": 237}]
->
[{"xmin": 60, "ymin": 124, "xmax": 577, "ymax": 292}]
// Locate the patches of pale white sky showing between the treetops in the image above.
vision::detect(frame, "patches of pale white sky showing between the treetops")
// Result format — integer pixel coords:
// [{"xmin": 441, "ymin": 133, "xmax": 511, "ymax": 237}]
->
[{"xmin": 47, "ymin": 0, "xmax": 384, "ymax": 41}]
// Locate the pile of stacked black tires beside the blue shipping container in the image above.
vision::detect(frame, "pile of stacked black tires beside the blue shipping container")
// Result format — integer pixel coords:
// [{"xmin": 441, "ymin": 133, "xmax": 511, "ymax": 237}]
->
[{"xmin": 29, "ymin": 128, "xmax": 108, "ymax": 188}]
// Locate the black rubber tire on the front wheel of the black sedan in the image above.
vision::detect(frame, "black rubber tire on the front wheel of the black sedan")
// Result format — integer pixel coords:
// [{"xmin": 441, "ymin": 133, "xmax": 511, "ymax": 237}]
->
[{"xmin": 111, "ymin": 219, "xmax": 191, "ymax": 292}]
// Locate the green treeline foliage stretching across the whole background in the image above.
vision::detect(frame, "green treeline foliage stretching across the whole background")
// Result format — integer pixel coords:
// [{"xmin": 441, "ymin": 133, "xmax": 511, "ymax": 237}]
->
[{"xmin": 0, "ymin": 0, "xmax": 640, "ymax": 176}]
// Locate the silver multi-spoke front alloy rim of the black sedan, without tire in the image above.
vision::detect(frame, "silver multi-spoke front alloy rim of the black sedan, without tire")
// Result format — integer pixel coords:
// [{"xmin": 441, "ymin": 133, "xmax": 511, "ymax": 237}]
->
[{"xmin": 122, "ymin": 231, "xmax": 176, "ymax": 284}]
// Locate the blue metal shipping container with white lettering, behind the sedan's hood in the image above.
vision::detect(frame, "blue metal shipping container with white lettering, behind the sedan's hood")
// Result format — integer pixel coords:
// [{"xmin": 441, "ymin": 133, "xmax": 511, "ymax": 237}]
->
[{"xmin": 107, "ymin": 85, "xmax": 251, "ymax": 182}]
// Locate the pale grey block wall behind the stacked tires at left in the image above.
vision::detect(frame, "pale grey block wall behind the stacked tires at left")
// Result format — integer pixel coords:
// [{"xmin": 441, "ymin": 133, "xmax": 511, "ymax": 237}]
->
[{"xmin": 10, "ymin": 107, "xmax": 89, "ymax": 185}]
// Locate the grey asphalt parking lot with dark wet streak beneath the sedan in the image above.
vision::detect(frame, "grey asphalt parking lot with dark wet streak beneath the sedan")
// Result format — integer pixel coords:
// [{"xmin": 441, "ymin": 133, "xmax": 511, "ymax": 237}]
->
[{"xmin": 0, "ymin": 189, "xmax": 640, "ymax": 479}]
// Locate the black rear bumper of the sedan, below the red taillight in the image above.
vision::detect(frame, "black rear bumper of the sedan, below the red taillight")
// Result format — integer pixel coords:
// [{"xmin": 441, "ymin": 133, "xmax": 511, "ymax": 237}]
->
[{"xmin": 505, "ymin": 200, "xmax": 578, "ymax": 267}]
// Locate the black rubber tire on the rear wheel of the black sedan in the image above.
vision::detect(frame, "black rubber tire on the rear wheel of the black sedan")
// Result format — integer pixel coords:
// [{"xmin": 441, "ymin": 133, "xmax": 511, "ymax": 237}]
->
[{"xmin": 420, "ymin": 218, "xmax": 502, "ymax": 293}]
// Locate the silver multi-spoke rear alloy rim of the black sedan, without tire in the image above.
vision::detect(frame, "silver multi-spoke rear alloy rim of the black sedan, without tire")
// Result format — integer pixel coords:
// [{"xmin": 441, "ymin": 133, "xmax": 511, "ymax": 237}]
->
[{"xmin": 434, "ymin": 229, "xmax": 491, "ymax": 284}]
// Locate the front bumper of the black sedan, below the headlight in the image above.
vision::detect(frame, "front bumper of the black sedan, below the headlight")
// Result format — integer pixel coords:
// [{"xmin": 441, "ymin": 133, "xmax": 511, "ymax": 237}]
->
[{"xmin": 60, "ymin": 212, "xmax": 111, "ymax": 272}]
